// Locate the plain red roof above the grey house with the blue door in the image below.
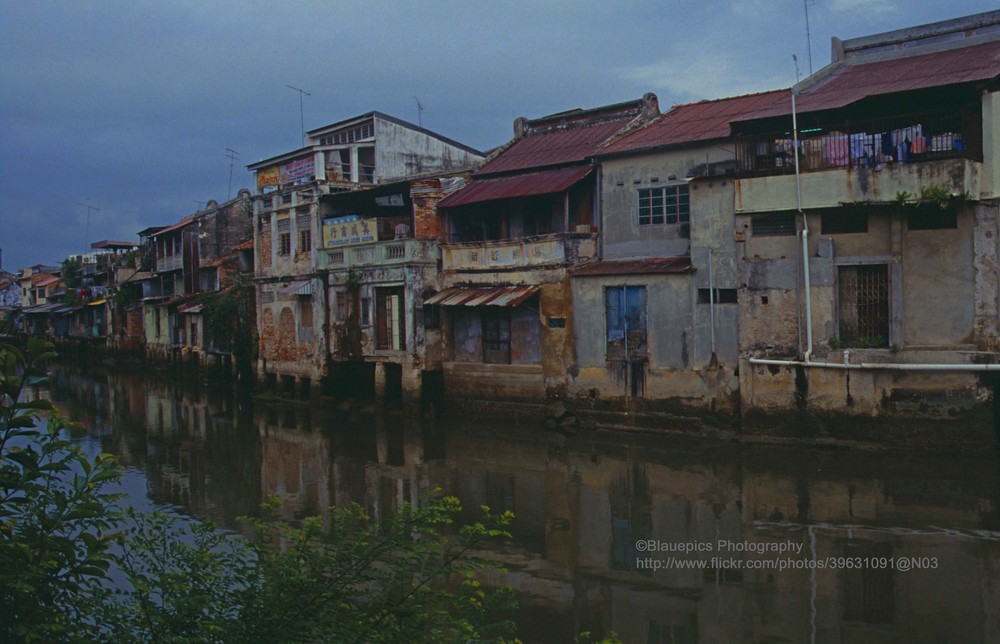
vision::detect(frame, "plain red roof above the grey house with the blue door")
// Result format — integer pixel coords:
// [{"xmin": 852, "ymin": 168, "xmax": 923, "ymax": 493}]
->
[{"xmin": 601, "ymin": 89, "xmax": 791, "ymax": 154}]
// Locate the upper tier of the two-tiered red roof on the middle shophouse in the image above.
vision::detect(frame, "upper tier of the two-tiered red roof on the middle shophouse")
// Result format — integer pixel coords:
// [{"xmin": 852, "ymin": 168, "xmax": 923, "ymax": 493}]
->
[{"xmin": 474, "ymin": 116, "xmax": 634, "ymax": 177}]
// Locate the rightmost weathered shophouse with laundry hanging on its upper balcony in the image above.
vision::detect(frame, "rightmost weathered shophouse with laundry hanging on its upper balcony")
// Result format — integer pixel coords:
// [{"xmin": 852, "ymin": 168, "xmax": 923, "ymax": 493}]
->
[{"xmin": 734, "ymin": 12, "xmax": 1000, "ymax": 415}]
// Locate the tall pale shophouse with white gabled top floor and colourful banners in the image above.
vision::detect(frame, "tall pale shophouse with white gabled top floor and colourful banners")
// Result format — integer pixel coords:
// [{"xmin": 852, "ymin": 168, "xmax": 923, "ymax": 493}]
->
[{"xmin": 248, "ymin": 112, "xmax": 482, "ymax": 393}]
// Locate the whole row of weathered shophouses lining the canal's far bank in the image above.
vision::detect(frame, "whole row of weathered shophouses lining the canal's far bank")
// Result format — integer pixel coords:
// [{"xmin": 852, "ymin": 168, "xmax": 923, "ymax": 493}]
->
[{"xmin": 11, "ymin": 11, "xmax": 1000, "ymax": 415}]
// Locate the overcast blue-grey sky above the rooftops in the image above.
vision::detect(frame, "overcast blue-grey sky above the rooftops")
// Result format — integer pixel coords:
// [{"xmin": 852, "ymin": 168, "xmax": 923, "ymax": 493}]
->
[{"xmin": 0, "ymin": 0, "xmax": 1000, "ymax": 271}]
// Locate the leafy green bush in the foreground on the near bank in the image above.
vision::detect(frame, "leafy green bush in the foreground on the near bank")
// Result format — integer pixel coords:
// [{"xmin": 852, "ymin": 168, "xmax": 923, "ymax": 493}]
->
[{"xmin": 0, "ymin": 340, "xmax": 514, "ymax": 642}]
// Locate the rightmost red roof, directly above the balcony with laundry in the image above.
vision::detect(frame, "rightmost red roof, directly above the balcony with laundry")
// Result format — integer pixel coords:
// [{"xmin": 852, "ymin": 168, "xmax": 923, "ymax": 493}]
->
[{"xmin": 738, "ymin": 40, "xmax": 1000, "ymax": 120}]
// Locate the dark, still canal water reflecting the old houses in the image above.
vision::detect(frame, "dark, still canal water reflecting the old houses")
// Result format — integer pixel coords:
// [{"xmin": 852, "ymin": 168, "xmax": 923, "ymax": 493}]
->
[{"xmin": 45, "ymin": 368, "xmax": 1000, "ymax": 643}]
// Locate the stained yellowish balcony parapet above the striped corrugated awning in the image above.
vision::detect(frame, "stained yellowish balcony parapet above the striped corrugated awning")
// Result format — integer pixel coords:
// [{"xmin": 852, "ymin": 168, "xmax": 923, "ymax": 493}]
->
[{"xmin": 441, "ymin": 233, "xmax": 597, "ymax": 272}]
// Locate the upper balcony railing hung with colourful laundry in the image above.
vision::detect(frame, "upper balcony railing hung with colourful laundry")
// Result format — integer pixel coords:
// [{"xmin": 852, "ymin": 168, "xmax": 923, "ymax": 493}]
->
[{"xmin": 736, "ymin": 109, "xmax": 983, "ymax": 176}]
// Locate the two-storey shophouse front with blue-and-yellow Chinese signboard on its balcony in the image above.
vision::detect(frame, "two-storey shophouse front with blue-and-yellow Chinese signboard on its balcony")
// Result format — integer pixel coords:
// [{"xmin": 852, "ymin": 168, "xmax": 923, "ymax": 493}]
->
[{"xmin": 317, "ymin": 171, "xmax": 469, "ymax": 399}]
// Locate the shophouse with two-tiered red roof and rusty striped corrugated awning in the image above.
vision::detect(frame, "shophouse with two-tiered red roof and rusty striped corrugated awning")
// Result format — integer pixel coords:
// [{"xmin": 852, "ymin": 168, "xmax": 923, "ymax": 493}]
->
[{"xmin": 427, "ymin": 94, "xmax": 659, "ymax": 400}]
